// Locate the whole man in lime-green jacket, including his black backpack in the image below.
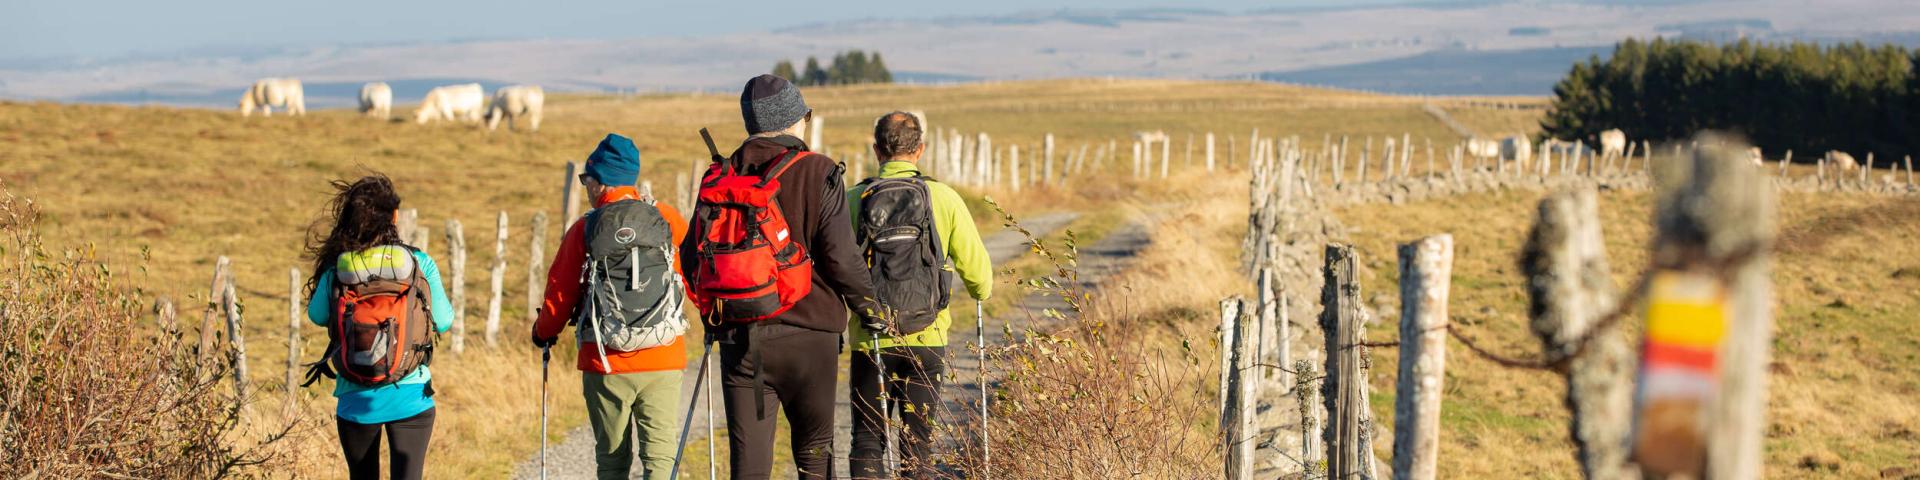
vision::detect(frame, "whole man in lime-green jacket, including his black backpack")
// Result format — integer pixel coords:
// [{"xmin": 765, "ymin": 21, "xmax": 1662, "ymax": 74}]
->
[{"xmin": 847, "ymin": 111, "xmax": 993, "ymax": 478}]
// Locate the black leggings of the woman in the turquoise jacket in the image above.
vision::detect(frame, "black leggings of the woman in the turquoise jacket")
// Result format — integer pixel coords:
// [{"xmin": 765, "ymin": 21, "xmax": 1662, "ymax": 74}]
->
[{"xmin": 334, "ymin": 409, "xmax": 434, "ymax": 480}]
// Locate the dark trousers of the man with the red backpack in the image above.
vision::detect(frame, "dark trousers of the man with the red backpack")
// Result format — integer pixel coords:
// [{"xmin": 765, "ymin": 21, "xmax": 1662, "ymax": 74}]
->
[{"xmin": 720, "ymin": 324, "xmax": 841, "ymax": 480}]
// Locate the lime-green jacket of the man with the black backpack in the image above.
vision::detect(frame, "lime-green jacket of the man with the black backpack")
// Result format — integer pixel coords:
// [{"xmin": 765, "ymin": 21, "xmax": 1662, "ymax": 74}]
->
[{"xmin": 847, "ymin": 161, "xmax": 993, "ymax": 351}]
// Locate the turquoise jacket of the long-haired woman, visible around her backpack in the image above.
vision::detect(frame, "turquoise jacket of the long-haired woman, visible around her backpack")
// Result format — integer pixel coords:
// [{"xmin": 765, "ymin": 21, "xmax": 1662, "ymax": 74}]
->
[{"xmin": 307, "ymin": 252, "xmax": 453, "ymax": 424}]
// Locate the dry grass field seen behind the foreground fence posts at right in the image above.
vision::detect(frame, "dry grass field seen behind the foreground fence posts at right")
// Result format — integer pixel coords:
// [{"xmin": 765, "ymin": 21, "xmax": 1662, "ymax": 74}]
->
[{"xmin": 1340, "ymin": 192, "xmax": 1920, "ymax": 478}]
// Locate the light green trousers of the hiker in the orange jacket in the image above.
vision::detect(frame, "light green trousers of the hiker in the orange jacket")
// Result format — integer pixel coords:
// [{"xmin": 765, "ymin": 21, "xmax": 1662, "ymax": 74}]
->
[{"xmin": 580, "ymin": 371, "xmax": 682, "ymax": 480}]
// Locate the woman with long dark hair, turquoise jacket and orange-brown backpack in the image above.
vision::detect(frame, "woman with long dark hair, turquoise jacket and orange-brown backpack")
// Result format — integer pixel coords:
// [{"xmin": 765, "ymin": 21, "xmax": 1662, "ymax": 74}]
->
[{"xmin": 303, "ymin": 175, "xmax": 453, "ymax": 480}]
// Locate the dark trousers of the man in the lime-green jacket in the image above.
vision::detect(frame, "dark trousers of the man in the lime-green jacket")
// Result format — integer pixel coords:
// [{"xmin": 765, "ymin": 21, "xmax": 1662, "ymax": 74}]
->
[{"xmin": 847, "ymin": 348, "xmax": 947, "ymax": 478}]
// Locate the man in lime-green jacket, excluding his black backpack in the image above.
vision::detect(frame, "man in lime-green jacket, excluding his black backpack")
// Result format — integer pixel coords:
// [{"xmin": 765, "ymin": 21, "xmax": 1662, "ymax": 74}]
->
[{"xmin": 847, "ymin": 111, "xmax": 993, "ymax": 478}]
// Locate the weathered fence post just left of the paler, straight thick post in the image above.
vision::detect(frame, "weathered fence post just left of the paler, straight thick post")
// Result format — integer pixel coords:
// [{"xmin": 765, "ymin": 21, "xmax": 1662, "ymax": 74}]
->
[{"xmin": 1321, "ymin": 245, "xmax": 1379, "ymax": 478}]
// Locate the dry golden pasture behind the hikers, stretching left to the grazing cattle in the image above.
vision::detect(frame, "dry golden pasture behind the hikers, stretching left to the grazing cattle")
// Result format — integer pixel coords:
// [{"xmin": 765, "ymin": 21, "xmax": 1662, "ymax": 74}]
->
[{"xmin": 0, "ymin": 81, "xmax": 1532, "ymax": 478}]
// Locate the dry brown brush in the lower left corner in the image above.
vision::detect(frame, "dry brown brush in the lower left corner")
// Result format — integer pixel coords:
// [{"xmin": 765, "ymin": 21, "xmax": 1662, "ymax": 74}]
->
[{"xmin": 0, "ymin": 190, "xmax": 294, "ymax": 478}]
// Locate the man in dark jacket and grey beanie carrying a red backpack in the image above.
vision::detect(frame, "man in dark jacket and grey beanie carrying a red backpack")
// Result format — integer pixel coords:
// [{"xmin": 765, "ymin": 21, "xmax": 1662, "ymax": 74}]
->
[{"xmin": 682, "ymin": 75, "xmax": 883, "ymax": 478}]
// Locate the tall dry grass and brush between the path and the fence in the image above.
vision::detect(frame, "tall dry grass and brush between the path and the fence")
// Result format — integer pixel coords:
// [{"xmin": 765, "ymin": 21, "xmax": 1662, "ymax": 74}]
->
[{"xmin": 929, "ymin": 198, "xmax": 1219, "ymax": 478}]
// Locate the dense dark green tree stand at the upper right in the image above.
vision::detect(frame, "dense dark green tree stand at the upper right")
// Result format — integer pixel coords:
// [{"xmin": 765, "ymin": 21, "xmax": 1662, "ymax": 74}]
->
[{"xmin": 1540, "ymin": 38, "xmax": 1920, "ymax": 161}]
